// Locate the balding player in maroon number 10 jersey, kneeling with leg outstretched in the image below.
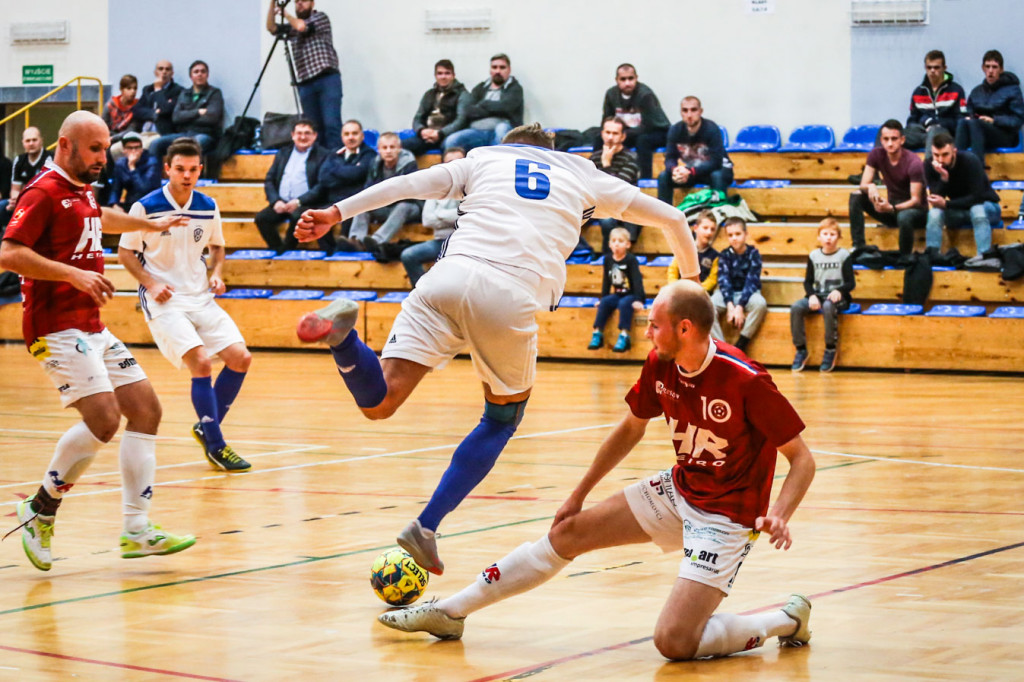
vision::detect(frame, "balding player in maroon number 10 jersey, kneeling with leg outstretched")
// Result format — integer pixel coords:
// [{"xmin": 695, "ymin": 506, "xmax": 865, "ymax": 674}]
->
[{"xmin": 378, "ymin": 282, "xmax": 814, "ymax": 660}]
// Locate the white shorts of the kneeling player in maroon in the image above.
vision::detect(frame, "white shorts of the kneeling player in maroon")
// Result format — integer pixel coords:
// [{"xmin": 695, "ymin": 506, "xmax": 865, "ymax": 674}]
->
[{"xmin": 624, "ymin": 470, "xmax": 760, "ymax": 595}]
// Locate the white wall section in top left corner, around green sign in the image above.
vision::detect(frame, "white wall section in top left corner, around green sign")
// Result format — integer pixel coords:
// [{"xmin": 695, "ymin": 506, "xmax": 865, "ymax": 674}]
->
[{"xmin": 0, "ymin": 0, "xmax": 108, "ymax": 87}]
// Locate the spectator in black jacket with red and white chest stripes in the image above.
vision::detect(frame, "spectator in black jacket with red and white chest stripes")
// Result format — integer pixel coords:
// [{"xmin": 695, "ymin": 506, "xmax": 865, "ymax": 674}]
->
[{"xmin": 904, "ymin": 50, "xmax": 967, "ymax": 153}]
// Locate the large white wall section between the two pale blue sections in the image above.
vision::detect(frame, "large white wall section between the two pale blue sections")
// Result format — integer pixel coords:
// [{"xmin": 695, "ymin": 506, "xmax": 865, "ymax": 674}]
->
[{"xmin": 261, "ymin": 0, "xmax": 850, "ymax": 135}]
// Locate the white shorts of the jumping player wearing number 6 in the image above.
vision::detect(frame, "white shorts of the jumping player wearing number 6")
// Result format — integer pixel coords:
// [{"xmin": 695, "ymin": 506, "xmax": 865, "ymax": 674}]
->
[{"xmin": 381, "ymin": 256, "xmax": 537, "ymax": 395}]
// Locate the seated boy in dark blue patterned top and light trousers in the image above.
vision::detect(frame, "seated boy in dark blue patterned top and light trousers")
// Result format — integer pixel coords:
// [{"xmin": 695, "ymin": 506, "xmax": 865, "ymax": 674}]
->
[{"xmin": 711, "ymin": 218, "xmax": 768, "ymax": 353}]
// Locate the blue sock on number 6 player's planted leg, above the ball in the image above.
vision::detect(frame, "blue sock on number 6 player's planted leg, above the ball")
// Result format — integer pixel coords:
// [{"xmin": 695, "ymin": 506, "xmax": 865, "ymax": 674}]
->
[{"xmin": 419, "ymin": 417, "xmax": 516, "ymax": 530}]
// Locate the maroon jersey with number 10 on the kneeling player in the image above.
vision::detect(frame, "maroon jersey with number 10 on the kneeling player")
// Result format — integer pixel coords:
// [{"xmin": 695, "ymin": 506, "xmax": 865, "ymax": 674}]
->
[{"xmin": 626, "ymin": 340, "xmax": 804, "ymax": 527}]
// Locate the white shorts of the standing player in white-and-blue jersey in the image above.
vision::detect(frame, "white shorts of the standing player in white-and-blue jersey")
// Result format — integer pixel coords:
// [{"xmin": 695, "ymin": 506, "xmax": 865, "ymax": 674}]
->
[{"xmin": 146, "ymin": 300, "xmax": 246, "ymax": 370}]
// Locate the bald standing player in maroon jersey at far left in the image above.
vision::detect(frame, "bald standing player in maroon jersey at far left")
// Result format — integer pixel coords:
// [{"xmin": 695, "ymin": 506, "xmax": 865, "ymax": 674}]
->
[{"xmin": 0, "ymin": 112, "xmax": 196, "ymax": 570}]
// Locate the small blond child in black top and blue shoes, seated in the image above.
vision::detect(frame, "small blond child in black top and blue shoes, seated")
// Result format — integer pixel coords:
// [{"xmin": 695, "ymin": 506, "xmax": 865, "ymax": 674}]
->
[{"xmin": 587, "ymin": 227, "xmax": 647, "ymax": 353}]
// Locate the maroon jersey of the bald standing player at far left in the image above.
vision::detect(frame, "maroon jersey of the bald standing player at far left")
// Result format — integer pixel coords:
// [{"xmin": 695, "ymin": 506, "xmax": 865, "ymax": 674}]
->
[{"xmin": 4, "ymin": 165, "xmax": 103, "ymax": 346}]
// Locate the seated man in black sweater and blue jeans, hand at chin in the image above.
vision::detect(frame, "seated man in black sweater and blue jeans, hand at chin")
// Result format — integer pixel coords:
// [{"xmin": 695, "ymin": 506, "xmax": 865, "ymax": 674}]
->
[{"xmin": 925, "ymin": 133, "xmax": 1002, "ymax": 267}]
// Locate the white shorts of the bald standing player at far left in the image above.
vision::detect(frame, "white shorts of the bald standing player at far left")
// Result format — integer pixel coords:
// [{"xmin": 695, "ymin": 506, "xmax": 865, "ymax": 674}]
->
[{"xmin": 29, "ymin": 329, "xmax": 145, "ymax": 408}]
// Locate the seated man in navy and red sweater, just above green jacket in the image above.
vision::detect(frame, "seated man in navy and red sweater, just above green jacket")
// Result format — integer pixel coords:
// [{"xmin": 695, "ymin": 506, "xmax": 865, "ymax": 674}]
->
[{"xmin": 657, "ymin": 95, "xmax": 732, "ymax": 204}]
